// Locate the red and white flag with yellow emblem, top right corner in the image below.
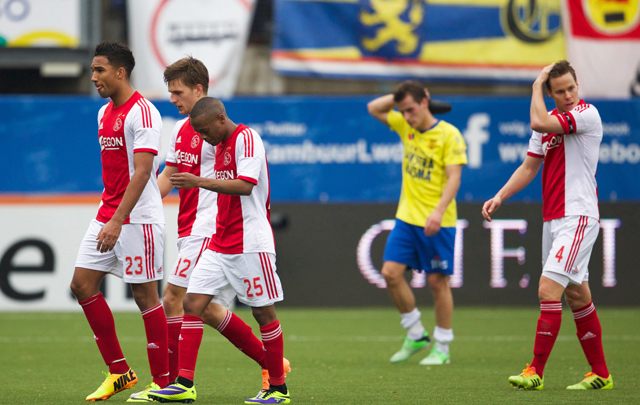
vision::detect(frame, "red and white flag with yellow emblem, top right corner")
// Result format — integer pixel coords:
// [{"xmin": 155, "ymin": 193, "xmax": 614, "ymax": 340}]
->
[{"xmin": 563, "ymin": 0, "xmax": 640, "ymax": 98}]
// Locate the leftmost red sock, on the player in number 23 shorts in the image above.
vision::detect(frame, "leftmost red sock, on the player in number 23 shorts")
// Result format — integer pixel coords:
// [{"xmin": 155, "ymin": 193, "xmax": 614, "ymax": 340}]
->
[{"xmin": 78, "ymin": 293, "xmax": 129, "ymax": 374}]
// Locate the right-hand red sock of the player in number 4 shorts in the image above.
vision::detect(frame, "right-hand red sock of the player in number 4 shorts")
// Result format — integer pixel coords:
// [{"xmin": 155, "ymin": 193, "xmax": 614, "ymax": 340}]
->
[{"xmin": 573, "ymin": 301, "xmax": 609, "ymax": 378}]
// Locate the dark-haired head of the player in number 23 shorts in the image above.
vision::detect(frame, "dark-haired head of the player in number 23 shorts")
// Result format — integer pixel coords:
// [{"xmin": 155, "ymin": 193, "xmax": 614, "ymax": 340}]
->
[{"xmin": 91, "ymin": 41, "xmax": 136, "ymax": 98}]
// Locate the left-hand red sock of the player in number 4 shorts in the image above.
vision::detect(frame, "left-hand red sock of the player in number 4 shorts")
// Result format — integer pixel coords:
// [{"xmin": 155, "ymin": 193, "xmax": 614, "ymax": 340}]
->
[{"xmin": 531, "ymin": 301, "xmax": 562, "ymax": 377}]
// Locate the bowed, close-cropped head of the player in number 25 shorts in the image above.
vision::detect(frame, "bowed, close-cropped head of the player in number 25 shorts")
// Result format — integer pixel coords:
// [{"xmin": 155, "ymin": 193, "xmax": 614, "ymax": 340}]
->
[{"xmin": 191, "ymin": 97, "xmax": 233, "ymax": 146}]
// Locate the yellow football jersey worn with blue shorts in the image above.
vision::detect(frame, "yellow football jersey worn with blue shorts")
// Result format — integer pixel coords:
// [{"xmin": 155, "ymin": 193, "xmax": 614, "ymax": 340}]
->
[{"xmin": 387, "ymin": 110, "xmax": 467, "ymax": 227}]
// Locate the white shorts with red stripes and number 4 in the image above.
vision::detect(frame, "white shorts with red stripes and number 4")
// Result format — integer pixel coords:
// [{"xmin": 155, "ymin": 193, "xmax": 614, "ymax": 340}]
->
[{"xmin": 542, "ymin": 215, "xmax": 600, "ymax": 287}]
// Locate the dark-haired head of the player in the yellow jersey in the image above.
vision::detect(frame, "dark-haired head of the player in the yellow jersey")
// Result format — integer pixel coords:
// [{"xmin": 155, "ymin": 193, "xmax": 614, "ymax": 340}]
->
[{"xmin": 393, "ymin": 80, "xmax": 433, "ymax": 130}]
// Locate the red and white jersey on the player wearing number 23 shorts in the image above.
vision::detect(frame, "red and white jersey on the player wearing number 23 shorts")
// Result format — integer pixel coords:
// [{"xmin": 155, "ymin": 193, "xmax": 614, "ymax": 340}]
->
[{"xmin": 96, "ymin": 92, "xmax": 164, "ymax": 224}]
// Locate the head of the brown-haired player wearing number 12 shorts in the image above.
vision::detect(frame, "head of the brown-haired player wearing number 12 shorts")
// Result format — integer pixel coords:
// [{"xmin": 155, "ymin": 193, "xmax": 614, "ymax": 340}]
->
[{"xmin": 164, "ymin": 56, "xmax": 209, "ymax": 115}]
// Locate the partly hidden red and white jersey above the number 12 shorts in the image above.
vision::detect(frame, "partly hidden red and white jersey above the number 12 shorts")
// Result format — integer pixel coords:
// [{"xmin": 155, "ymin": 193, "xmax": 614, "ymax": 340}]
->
[{"xmin": 167, "ymin": 117, "xmax": 218, "ymax": 238}]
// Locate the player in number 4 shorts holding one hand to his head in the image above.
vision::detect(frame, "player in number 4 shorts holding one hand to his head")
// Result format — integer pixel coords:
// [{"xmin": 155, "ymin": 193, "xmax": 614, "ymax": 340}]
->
[{"xmin": 482, "ymin": 60, "xmax": 613, "ymax": 390}]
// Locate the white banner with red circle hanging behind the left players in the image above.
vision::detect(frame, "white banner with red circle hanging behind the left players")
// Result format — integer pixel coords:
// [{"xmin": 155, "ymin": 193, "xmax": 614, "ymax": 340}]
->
[{"xmin": 127, "ymin": 0, "xmax": 256, "ymax": 98}]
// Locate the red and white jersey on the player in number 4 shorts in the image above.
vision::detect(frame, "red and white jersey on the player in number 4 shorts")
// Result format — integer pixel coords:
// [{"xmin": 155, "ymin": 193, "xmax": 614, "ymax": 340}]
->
[{"xmin": 527, "ymin": 100, "xmax": 602, "ymax": 221}]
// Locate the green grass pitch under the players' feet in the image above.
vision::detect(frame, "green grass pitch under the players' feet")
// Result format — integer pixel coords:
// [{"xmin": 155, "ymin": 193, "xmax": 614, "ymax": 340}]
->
[{"xmin": 0, "ymin": 306, "xmax": 640, "ymax": 404}]
